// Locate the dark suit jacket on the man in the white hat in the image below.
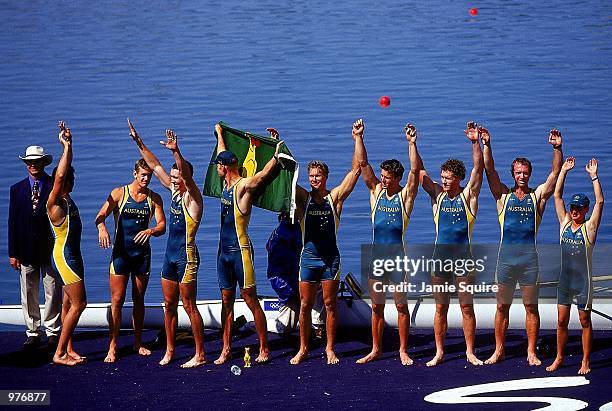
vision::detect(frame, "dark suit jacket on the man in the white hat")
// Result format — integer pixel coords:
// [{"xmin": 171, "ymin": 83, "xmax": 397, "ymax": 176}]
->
[{"xmin": 8, "ymin": 173, "xmax": 53, "ymax": 265}]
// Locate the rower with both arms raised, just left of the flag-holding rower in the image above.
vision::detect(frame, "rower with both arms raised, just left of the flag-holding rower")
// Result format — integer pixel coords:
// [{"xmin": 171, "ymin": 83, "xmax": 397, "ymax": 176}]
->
[{"xmin": 128, "ymin": 119, "xmax": 206, "ymax": 368}]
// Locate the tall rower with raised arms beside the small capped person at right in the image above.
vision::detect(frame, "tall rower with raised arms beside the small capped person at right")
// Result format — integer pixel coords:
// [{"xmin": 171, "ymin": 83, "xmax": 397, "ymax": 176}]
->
[{"xmin": 481, "ymin": 129, "xmax": 563, "ymax": 366}]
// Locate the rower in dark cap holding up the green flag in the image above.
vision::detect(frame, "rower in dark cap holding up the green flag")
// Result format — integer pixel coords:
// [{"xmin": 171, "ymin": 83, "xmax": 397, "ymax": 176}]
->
[{"xmin": 213, "ymin": 124, "xmax": 284, "ymax": 364}]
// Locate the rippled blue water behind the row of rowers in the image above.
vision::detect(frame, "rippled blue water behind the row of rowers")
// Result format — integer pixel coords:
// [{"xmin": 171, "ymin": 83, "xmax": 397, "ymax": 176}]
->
[{"xmin": 0, "ymin": 0, "xmax": 612, "ymax": 304}]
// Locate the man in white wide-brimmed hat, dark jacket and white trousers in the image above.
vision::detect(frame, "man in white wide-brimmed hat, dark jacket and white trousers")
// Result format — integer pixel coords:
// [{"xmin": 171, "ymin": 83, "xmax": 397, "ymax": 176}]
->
[{"xmin": 8, "ymin": 146, "xmax": 62, "ymax": 348}]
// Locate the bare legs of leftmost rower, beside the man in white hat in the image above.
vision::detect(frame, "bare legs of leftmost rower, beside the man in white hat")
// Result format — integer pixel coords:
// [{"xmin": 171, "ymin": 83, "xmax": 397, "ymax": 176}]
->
[{"xmin": 53, "ymin": 281, "xmax": 87, "ymax": 365}]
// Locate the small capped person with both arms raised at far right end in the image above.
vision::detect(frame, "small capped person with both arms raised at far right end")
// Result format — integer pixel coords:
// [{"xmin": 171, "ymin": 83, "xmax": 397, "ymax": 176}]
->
[{"xmin": 546, "ymin": 157, "xmax": 604, "ymax": 375}]
